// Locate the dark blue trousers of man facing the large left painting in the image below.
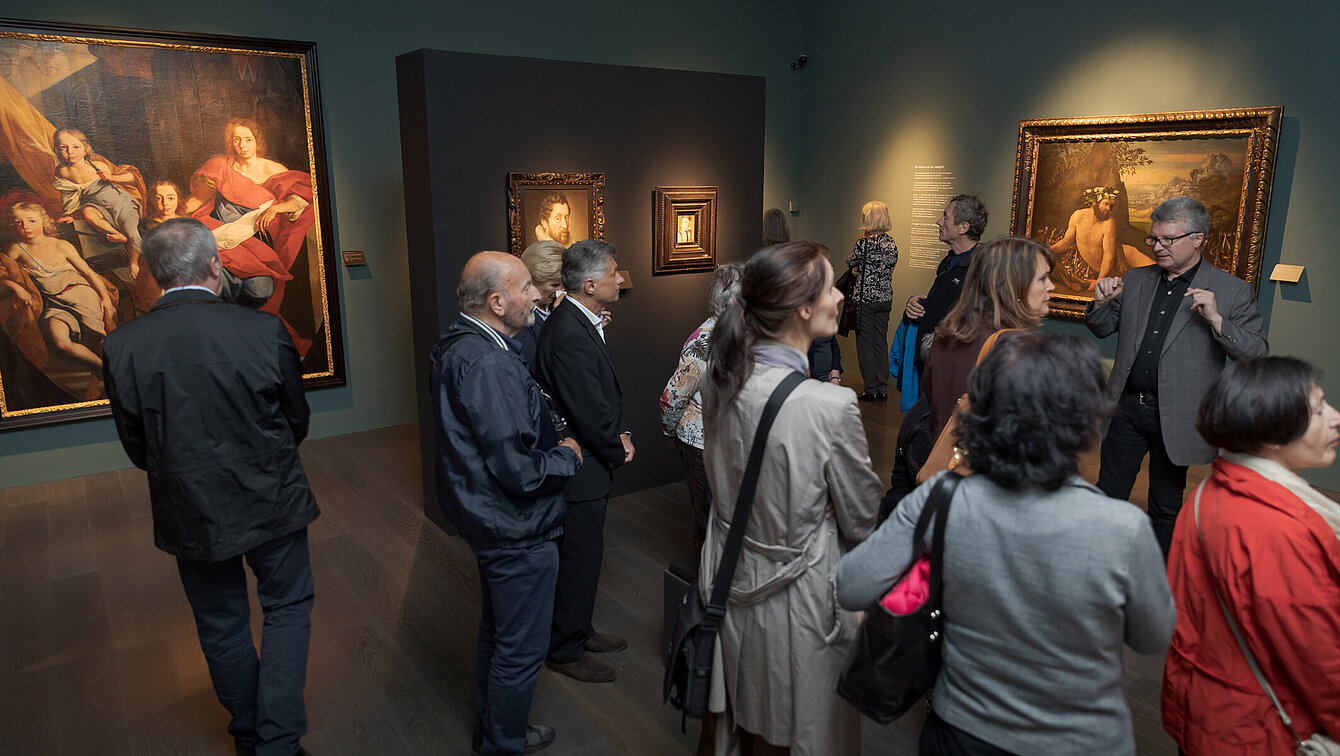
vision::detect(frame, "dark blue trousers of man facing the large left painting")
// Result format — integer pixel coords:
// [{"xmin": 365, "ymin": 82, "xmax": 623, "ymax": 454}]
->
[{"xmin": 177, "ymin": 528, "xmax": 314, "ymax": 756}]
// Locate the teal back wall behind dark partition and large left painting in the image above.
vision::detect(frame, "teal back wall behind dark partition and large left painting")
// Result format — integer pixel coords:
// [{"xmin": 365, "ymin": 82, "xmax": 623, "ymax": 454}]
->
[{"xmin": 0, "ymin": 0, "xmax": 803, "ymax": 488}]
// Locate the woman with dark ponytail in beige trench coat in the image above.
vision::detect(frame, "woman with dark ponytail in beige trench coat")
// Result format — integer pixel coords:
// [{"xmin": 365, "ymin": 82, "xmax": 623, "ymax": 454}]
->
[{"xmin": 699, "ymin": 241, "xmax": 882, "ymax": 756}]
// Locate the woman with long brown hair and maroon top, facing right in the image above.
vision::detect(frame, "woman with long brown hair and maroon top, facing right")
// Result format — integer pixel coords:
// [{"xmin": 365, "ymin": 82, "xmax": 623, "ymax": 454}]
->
[{"xmin": 922, "ymin": 237, "xmax": 1056, "ymax": 438}]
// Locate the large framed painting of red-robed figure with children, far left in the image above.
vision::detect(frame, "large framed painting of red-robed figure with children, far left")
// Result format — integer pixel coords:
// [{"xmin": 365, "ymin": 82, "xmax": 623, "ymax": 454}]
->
[{"xmin": 0, "ymin": 19, "xmax": 344, "ymax": 429}]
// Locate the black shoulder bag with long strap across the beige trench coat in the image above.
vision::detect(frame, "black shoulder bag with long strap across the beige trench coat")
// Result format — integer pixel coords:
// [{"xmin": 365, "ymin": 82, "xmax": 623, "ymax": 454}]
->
[{"xmin": 662, "ymin": 373, "xmax": 805, "ymax": 731}]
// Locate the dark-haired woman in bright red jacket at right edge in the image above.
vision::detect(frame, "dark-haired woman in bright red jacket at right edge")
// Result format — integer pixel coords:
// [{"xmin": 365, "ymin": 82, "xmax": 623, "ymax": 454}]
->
[{"xmin": 1163, "ymin": 357, "xmax": 1340, "ymax": 756}]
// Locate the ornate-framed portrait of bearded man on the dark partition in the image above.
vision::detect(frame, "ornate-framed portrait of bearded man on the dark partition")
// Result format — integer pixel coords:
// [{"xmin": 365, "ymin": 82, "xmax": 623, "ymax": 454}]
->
[{"xmin": 507, "ymin": 173, "xmax": 604, "ymax": 255}]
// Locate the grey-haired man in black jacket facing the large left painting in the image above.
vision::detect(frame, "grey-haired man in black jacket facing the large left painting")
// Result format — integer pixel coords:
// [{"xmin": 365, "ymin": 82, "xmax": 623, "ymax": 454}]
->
[{"xmin": 103, "ymin": 218, "xmax": 318, "ymax": 756}]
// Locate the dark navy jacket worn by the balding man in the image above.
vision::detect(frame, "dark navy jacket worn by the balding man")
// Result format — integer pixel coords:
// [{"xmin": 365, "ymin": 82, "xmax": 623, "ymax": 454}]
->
[{"xmin": 430, "ymin": 318, "xmax": 578, "ymax": 547}]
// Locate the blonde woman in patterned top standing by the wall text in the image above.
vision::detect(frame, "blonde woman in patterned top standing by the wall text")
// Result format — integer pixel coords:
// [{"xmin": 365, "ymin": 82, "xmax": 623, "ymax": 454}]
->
[{"xmin": 847, "ymin": 200, "xmax": 898, "ymax": 402}]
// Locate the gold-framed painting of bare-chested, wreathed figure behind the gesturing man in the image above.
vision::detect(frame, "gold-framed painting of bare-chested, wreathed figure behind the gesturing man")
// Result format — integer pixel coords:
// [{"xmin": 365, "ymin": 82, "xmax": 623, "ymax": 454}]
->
[{"xmin": 1010, "ymin": 106, "xmax": 1284, "ymax": 318}]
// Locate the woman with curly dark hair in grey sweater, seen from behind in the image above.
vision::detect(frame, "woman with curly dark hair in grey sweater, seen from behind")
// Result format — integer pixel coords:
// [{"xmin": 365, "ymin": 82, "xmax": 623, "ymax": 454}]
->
[{"xmin": 838, "ymin": 331, "xmax": 1175, "ymax": 756}]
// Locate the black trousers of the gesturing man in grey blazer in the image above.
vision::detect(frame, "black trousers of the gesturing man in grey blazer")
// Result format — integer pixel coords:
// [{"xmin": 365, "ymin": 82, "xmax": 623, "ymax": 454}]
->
[{"xmin": 1097, "ymin": 394, "xmax": 1186, "ymax": 559}]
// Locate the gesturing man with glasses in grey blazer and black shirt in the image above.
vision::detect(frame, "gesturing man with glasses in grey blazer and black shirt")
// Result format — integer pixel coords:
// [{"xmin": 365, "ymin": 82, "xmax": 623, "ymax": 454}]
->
[{"xmin": 1084, "ymin": 196, "xmax": 1268, "ymax": 556}]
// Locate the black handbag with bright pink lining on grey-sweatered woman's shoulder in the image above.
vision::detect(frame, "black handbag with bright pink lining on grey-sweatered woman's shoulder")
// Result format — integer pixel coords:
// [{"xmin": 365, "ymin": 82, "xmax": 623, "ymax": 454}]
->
[{"xmin": 838, "ymin": 475, "xmax": 962, "ymax": 724}]
